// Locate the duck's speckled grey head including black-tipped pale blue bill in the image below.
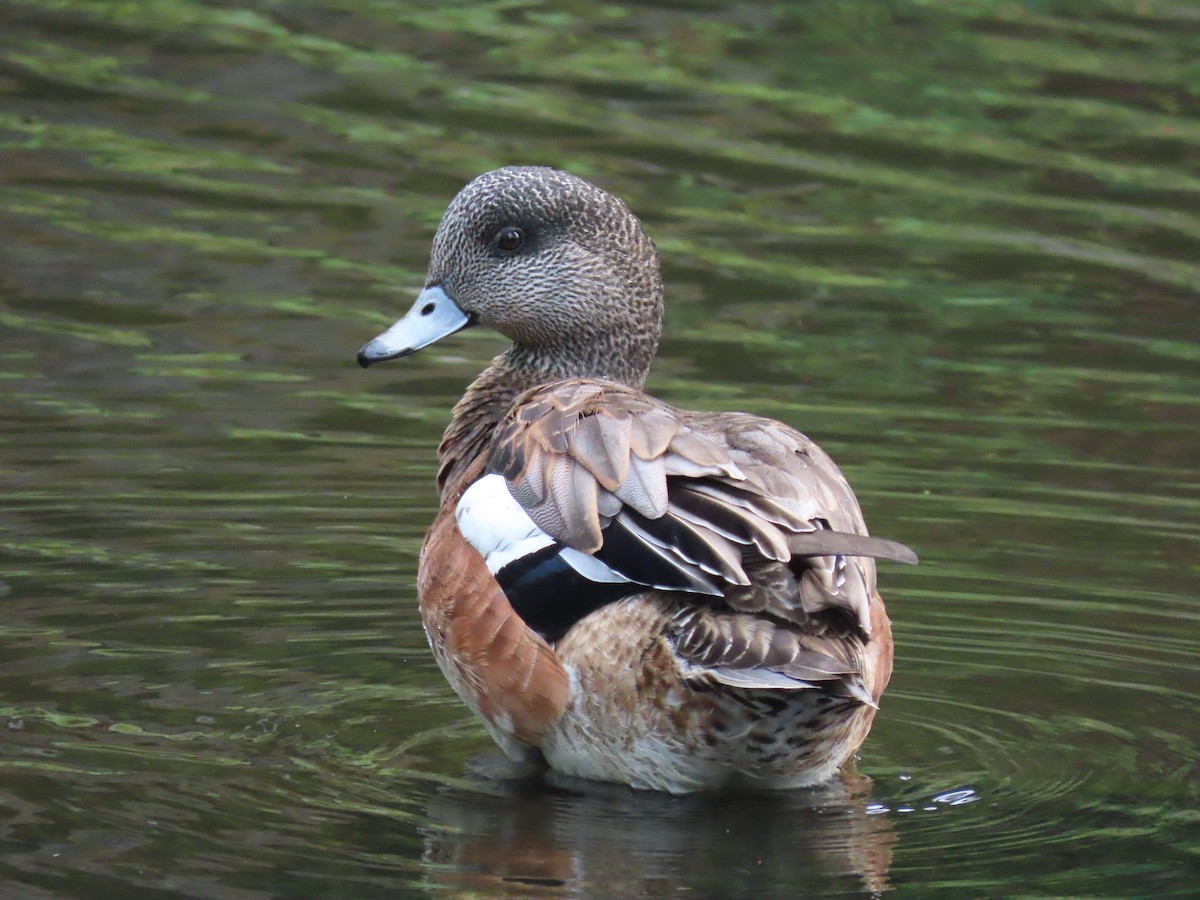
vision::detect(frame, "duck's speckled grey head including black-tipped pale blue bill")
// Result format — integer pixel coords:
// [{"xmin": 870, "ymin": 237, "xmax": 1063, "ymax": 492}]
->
[{"xmin": 359, "ymin": 167, "xmax": 662, "ymax": 386}]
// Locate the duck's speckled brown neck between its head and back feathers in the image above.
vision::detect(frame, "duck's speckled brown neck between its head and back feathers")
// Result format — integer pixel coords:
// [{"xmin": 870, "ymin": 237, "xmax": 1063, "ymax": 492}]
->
[{"xmin": 438, "ymin": 334, "xmax": 658, "ymax": 500}]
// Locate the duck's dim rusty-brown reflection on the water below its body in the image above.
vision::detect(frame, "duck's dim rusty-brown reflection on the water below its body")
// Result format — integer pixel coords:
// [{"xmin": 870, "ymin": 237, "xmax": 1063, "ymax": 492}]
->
[{"xmin": 424, "ymin": 772, "xmax": 896, "ymax": 898}]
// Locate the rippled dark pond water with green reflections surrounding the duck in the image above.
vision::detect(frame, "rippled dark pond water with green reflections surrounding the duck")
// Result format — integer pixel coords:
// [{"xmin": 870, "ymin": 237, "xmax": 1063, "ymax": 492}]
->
[{"xmin": 0, "ymin": 0, "xmax": 1200, "ymax": 899}]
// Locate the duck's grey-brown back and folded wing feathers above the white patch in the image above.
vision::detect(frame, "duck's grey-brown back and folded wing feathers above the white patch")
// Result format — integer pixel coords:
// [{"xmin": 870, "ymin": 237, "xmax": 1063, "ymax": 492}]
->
[{"xmin": 491, "ymin": 379, "xmax": 916, "ymax": 634}]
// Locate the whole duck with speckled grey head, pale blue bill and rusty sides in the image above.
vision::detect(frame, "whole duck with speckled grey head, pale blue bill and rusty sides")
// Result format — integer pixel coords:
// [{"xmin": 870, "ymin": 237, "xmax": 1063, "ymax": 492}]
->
[{"xmin": 358, "ymin": 166, "xmax": 917, "ymax": 794}]
